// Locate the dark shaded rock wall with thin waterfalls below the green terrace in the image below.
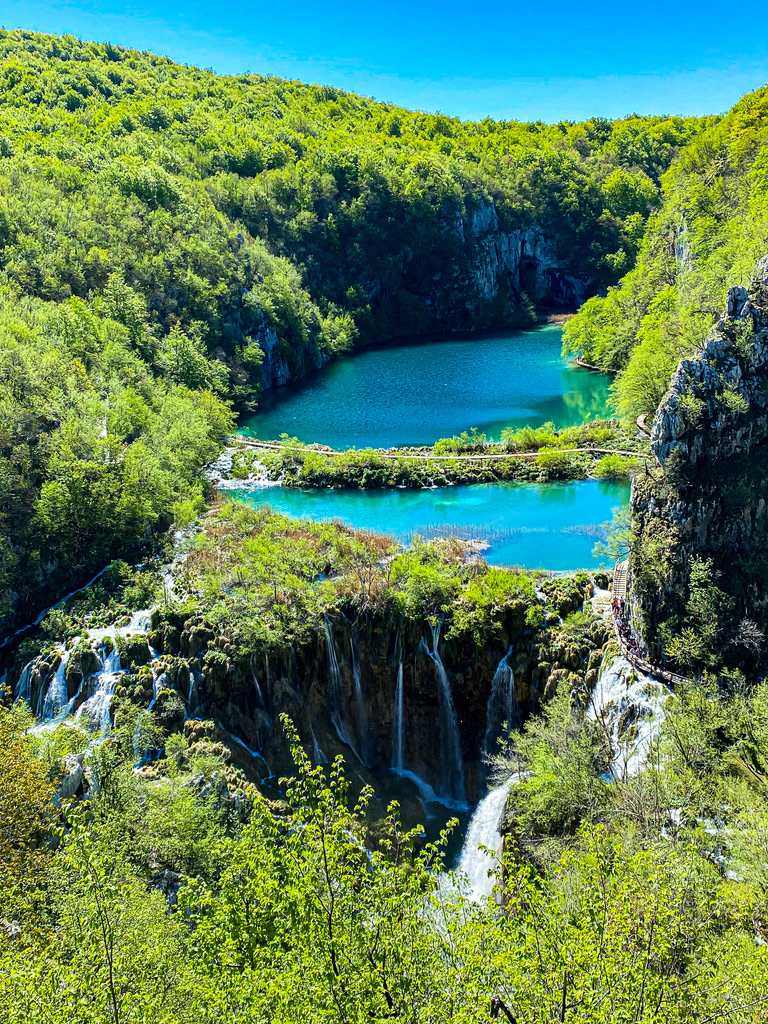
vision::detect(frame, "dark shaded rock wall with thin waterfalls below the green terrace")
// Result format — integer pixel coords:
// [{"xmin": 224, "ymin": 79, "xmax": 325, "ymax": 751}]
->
[{"xmin": 150, "ymin": 588, "xmax": 603, "ymax": 800}]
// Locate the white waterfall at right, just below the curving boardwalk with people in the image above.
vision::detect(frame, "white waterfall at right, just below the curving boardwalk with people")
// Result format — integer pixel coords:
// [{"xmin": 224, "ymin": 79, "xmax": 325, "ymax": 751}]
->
[{"xmin": 587, "ymin": 657, "xmax": 670, "ymax": 778}]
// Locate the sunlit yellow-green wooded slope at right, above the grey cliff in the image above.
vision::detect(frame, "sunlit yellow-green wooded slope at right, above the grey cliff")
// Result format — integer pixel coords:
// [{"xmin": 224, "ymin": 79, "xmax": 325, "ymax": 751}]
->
[{"xmin": 565, "ymin": 81, "xmax": 768, "ymax": 419}]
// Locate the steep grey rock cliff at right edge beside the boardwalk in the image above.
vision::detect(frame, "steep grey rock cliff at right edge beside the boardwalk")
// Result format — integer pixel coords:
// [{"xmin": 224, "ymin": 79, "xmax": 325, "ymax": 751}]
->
[{"xmin": 631, "ymin": 258, "xmax": 768, "ymax": 665}]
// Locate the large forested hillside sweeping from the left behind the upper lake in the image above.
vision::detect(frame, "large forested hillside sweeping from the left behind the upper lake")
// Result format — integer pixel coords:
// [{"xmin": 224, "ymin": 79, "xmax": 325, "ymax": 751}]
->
[{"xmin": 0, "ymin": 32, "xmax": 709, "ymax": 632}]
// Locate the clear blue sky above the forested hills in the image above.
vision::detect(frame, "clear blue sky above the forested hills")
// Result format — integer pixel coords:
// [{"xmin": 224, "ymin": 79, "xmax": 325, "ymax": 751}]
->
[{"xmin": 0, "ymin": 0, "xmax": 768, "ymax": 121}]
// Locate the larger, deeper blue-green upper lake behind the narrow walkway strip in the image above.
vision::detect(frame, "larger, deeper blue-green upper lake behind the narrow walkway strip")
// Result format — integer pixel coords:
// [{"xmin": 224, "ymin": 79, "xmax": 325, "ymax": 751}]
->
[{"xmin": 241, "ymin": 325, "xmax": 611, "ymax": 449}]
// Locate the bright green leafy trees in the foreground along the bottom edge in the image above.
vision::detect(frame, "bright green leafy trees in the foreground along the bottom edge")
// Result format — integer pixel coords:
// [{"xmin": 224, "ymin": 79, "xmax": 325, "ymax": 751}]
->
[{"xmin": 0, "ymin": 695, "xmax": 768, "ymax": 1024}]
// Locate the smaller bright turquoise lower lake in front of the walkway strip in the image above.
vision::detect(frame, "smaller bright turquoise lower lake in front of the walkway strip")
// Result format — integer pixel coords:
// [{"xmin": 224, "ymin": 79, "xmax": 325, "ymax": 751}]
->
[{"xmin": 226, "ymin": 480, "xmax": 630, "ymax": 571}]
